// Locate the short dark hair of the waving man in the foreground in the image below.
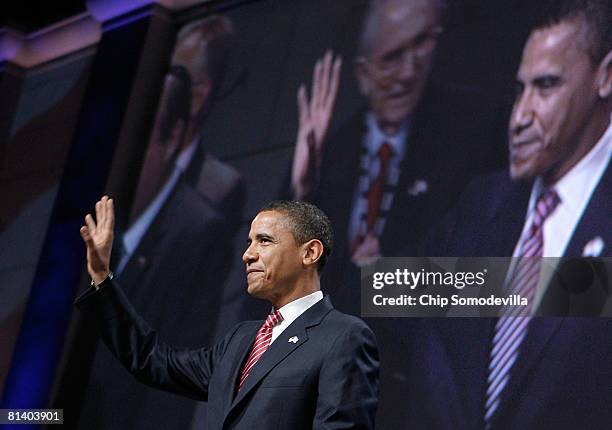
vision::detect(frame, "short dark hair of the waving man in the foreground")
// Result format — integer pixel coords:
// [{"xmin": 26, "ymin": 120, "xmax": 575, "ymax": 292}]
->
[{"xmin": 259, "ymin": 200, "xmax": 333, "ymax": 273}]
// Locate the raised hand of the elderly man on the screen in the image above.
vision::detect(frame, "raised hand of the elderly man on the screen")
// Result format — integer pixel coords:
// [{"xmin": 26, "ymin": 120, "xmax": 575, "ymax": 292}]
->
[{"xmin": 291, "ymin": 51, "xmax": 342, "ymax": 200}]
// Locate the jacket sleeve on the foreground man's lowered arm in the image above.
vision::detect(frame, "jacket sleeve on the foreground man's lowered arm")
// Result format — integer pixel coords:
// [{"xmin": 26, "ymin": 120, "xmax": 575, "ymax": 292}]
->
[{"xmin": 313, "ymin": 321, "xmax": 379, "ymax": 430}]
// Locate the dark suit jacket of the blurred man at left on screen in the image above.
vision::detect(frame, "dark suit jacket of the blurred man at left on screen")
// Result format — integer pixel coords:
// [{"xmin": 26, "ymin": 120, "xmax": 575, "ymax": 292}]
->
[{"xmin": 79, "ymin": 179, "xmax": 231, "ymax": 430}]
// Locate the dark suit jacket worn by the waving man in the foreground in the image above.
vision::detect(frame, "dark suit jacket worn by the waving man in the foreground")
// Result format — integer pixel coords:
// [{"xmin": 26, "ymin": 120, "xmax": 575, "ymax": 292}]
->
[{"xmin": 76, "ymin": 281, "xmax": 378, "ymax": 430}]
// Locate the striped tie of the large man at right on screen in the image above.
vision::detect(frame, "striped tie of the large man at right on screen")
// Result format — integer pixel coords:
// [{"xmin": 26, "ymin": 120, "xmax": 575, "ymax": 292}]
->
[{"xmin": 485, "ymin": 189, "xmax": 561, "ymax": 428}]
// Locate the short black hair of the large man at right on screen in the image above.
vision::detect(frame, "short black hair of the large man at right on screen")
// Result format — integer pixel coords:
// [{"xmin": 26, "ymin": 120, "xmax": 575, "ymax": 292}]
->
[{"xmin": 532, "ymin": 0, "xmax": 612, "ymax": 64}]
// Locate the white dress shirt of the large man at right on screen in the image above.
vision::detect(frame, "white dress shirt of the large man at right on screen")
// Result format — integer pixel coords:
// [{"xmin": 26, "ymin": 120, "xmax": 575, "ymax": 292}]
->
[{"xmin": 513, "ymin": 118, "xmax": 612, "ymax": 307}]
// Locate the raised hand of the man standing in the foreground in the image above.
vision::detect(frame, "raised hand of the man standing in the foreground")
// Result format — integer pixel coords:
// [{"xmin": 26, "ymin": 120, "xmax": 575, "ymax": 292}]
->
[{"xmin": 80, "ymin": 196, "xmax": 115, "ymax": 285}]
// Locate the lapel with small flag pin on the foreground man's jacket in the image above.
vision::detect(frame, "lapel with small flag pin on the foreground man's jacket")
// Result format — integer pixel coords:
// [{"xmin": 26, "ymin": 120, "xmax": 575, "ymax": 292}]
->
[{"xmin": 225, "ymin": 297, "xmax": 333, "ymax": 419}]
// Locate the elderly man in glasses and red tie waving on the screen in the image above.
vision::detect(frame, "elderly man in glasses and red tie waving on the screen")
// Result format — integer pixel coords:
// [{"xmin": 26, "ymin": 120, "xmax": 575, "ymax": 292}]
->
[{"xmin": 291, "ymin": 0, "xmax": 503, "ymax": 312}]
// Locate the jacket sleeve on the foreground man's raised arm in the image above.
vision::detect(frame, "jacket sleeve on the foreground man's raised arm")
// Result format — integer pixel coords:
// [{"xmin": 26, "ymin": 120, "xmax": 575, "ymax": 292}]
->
[{"xmin": 74, "ymin": 279, "xmax": 238, "ymax": 400}]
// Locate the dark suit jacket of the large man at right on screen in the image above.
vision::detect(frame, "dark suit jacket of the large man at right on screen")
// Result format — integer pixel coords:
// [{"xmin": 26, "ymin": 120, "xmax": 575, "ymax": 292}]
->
[{"xmin": 404, "ymin": 161, "xmax": 612, "ymax": 429}]
